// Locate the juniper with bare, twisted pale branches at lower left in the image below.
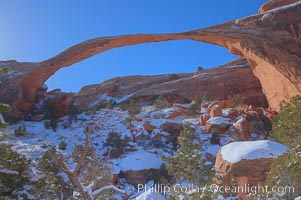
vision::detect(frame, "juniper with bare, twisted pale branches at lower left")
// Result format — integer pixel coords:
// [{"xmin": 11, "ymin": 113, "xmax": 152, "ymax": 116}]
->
[{"xmin": 39, "ymin": 127, "xmax": 131, "ymax": 200}]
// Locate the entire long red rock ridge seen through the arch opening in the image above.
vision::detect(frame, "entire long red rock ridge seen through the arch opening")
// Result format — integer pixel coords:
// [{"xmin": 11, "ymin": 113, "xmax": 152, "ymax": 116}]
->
[{"xmin": 35, "ymin": 58, "xmax": 268, "ymax": 116}]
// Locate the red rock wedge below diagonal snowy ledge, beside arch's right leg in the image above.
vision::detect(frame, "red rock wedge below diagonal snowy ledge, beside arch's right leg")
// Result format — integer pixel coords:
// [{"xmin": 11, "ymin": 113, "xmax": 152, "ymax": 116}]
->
[{"xmin": 132, "ymin": 59, "xmax": 267, "ymax": 107}]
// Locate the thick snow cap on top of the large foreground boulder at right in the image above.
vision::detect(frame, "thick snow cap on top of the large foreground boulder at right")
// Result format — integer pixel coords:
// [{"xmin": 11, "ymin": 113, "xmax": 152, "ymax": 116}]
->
[{"xmin": 221, "ymin": 140, "xmax": 288, "ymax": 163}]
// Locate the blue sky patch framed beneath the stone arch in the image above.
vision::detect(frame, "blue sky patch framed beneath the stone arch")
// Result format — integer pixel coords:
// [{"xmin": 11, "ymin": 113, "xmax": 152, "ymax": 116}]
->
[{"xmin": 45, "ymin": 40, "xmax": 237, "ymax": 92}]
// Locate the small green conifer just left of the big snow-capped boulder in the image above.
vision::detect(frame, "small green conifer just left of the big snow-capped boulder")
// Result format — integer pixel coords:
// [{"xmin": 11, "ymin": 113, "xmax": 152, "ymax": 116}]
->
[{"xmin": 163, "ymin": 124, "xmax": 213, "ymax": 199}]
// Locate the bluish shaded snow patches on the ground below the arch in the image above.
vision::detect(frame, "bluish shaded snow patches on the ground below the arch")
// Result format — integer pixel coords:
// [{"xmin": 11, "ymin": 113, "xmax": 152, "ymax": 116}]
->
[{"xmin": 0, "ymin": 106, "xmax": 255, "ymax": 200}]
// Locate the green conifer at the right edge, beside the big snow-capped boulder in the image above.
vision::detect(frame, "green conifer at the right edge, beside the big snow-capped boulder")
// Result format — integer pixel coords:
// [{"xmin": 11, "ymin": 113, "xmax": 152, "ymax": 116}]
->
[{"xmin": 267, "ymin": 96, "xmax": 301, "ymax": 199}]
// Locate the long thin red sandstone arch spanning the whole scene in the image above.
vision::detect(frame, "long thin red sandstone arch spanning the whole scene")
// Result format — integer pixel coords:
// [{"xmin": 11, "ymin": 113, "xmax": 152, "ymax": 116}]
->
[{"xmin": 0, "ymin": 0, "xmax": 301, "ymax": 115}]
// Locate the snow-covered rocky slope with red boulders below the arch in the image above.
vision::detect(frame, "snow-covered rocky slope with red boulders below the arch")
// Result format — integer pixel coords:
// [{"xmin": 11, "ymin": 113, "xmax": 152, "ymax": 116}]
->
[{"xmin": 0, "ymin": 97, "xmax": 285, "ymax": 199}]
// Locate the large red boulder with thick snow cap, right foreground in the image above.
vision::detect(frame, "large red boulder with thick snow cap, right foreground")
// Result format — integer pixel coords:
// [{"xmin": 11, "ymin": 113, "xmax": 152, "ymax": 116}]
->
[{"xmin": 215, "ymin": 140, "xmax": 287, "ymax": 196}]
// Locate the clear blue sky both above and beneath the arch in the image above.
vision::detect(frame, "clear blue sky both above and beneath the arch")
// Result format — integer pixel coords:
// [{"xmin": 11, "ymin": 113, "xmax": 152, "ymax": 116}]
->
[{"xmin": 0, "ymin": 0, "xmax": 265, "ymax": 91}]
